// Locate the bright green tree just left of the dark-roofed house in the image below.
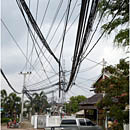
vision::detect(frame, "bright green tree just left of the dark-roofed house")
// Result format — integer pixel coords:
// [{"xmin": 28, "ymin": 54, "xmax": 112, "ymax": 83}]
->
[{"xmin": 64, "ymin": 95, "xmax": 86, "ymax": 114}]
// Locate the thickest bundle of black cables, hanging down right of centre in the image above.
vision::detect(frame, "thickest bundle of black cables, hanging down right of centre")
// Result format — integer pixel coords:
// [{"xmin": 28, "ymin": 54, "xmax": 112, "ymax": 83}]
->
[{"xmin": 65, "ymin": 0, "xmax": 98, "ymax": 92}]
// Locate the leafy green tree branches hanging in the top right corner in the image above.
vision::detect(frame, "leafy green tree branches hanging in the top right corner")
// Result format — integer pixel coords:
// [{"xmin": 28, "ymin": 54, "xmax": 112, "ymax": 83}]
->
[{"xmin": 99, "ymin": 0, "xmax": 129, "ymax": 47}]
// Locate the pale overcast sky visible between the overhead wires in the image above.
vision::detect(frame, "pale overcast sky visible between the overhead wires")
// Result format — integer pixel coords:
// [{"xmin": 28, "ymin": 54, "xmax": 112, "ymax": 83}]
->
[{"xmin": 1, "ymin": 0, "xmax": 126, "ymax": 99}]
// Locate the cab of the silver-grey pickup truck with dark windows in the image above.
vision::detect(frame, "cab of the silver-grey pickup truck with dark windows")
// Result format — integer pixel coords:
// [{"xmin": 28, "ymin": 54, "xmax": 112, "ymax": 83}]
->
[{"xmin": 60, "ymin": 118, "xmax": 102, "ymax": 130}]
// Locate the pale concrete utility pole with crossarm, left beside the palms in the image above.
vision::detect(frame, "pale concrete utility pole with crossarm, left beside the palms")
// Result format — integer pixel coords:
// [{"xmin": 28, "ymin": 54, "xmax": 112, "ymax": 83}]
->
[{"xmin": 20, "ymin": 72, "xmax": 31, "ymax": 123}]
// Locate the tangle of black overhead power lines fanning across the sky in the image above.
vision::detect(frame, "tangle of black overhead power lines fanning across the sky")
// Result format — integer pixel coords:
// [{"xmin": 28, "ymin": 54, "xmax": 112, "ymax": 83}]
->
[{"xmin": 1, "ymin": 0, "xmax": 124, "ymax": 99}]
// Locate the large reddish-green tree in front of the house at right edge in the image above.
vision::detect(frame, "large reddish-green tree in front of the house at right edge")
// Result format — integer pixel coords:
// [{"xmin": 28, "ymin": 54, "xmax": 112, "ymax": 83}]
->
[{"xmin": 96, "ymin": 59, "xmax": 129, "ymax": 130}]
